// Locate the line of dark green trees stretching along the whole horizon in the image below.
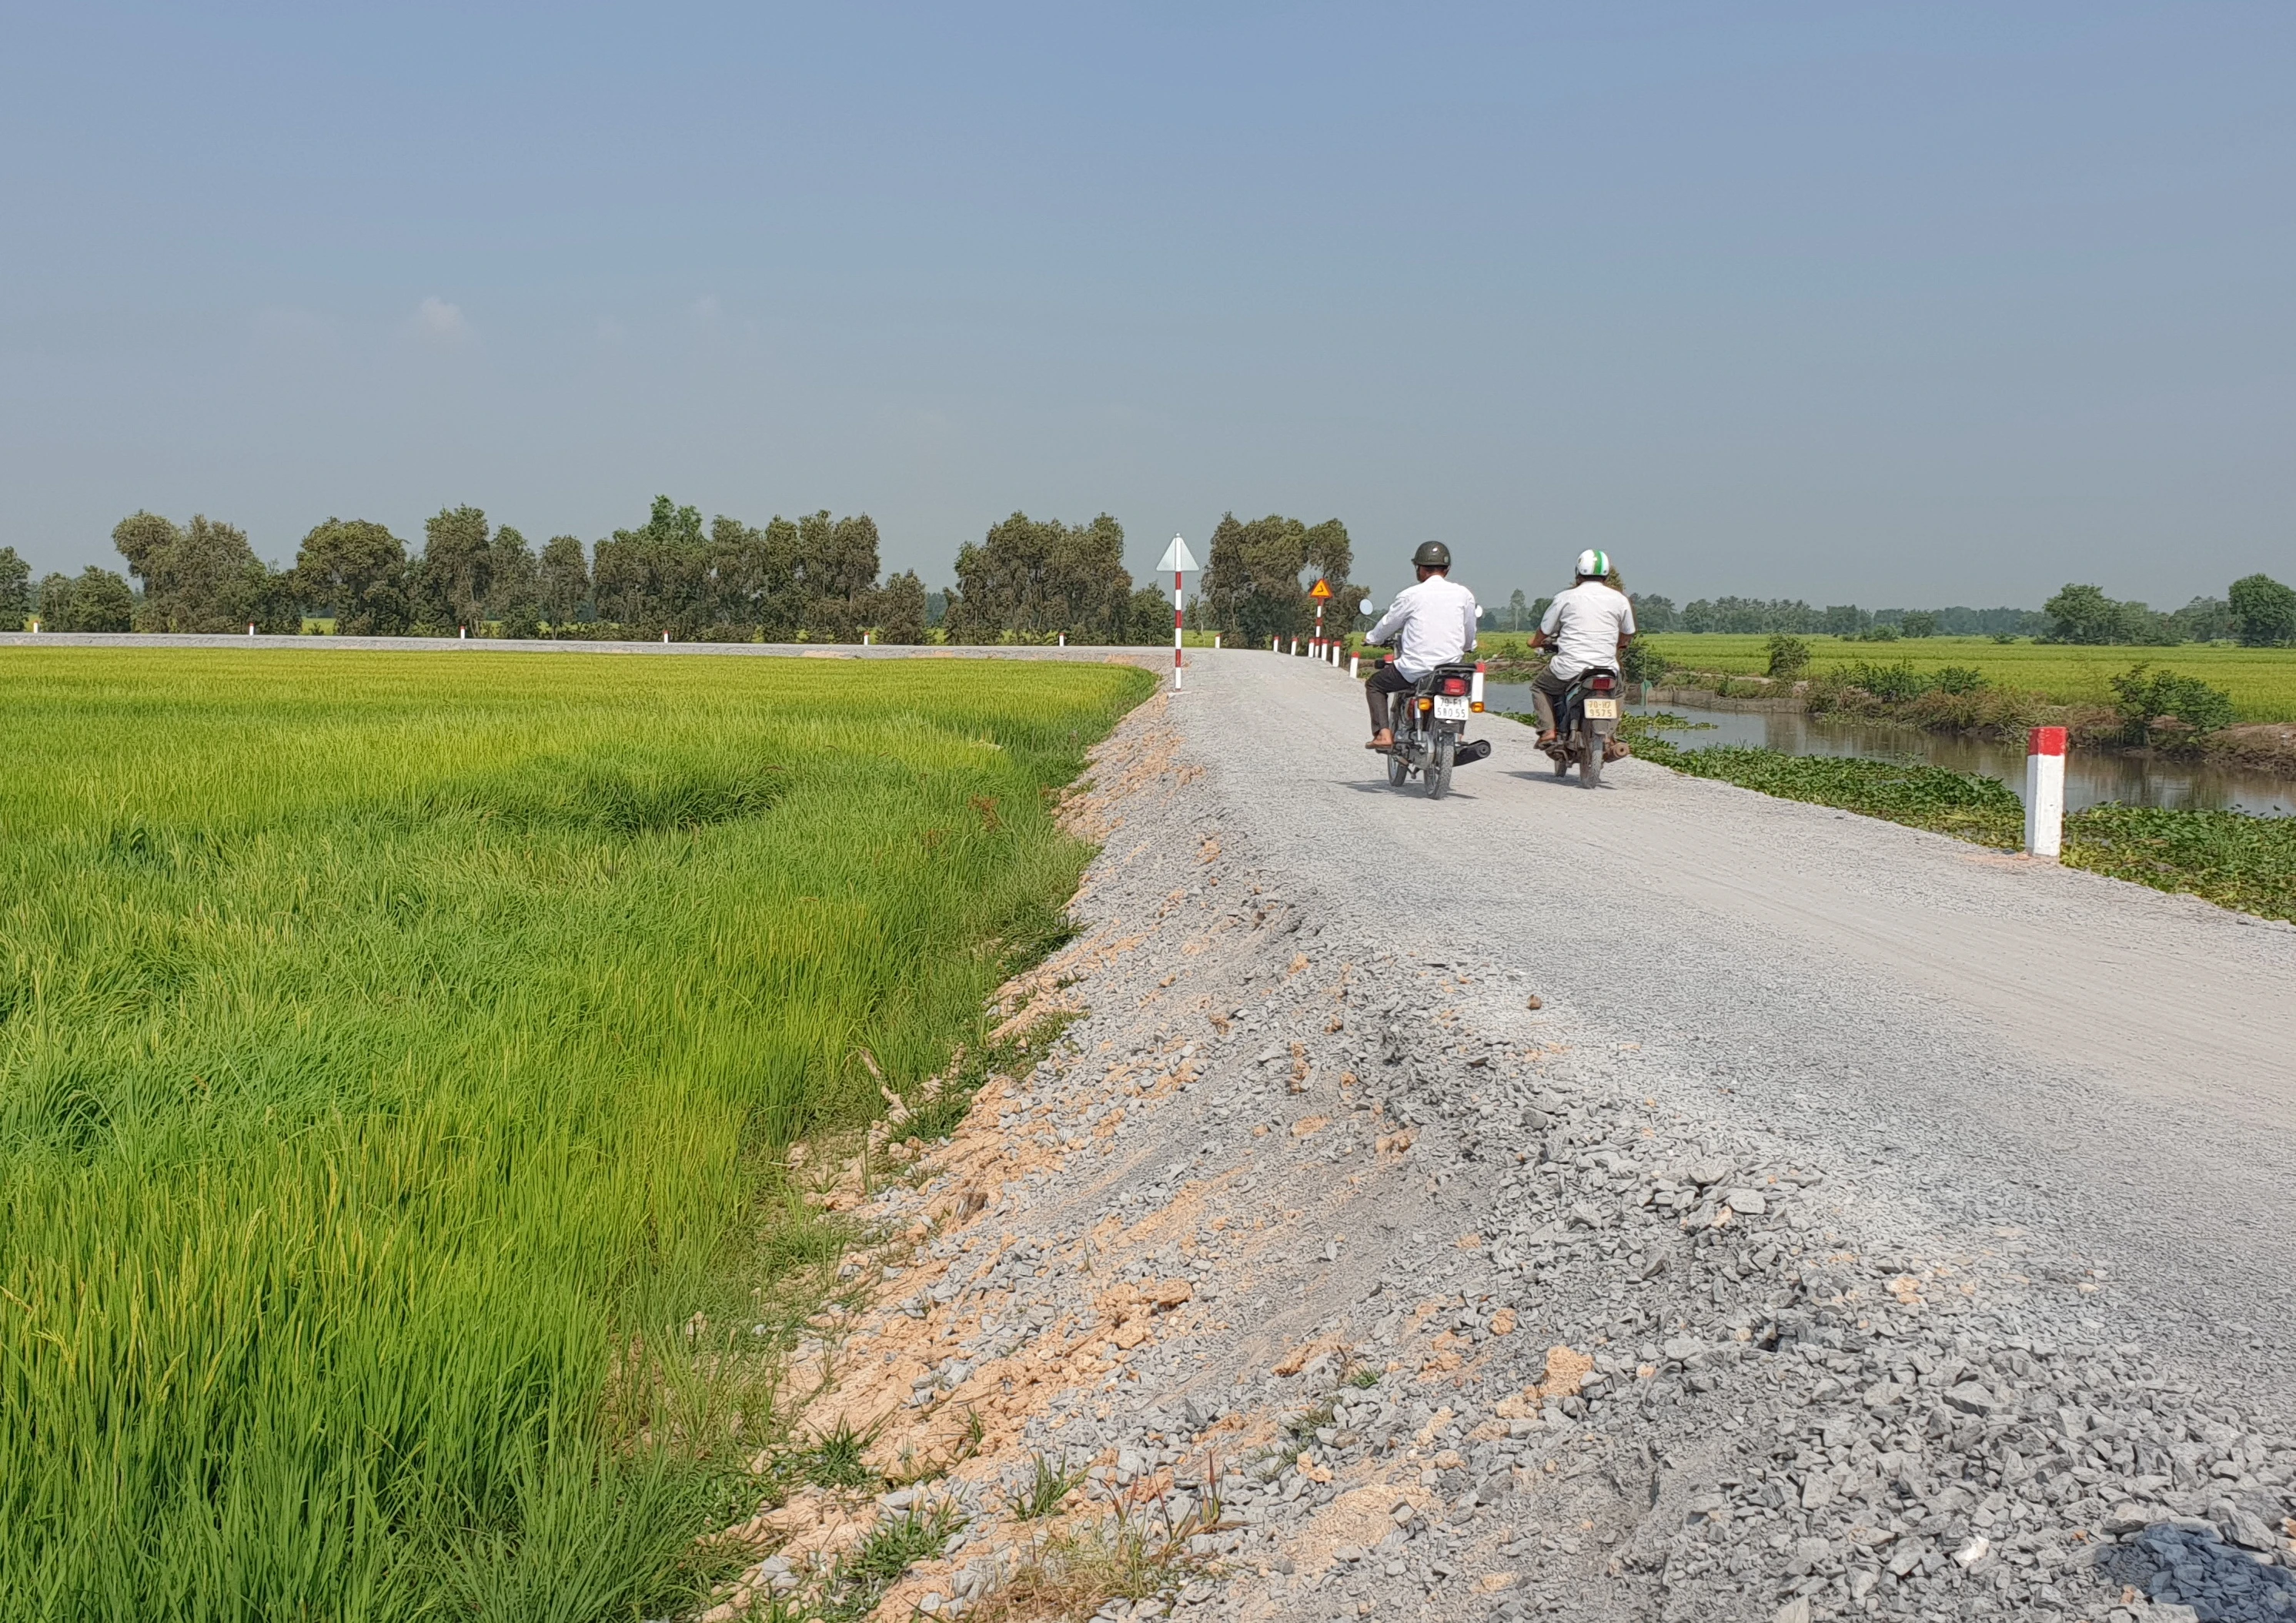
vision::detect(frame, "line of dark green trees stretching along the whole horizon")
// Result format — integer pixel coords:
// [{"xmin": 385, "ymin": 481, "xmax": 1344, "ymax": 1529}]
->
[{"xmin": 0, "ymin": 511, "xmax": 2296, "ymax": 645}]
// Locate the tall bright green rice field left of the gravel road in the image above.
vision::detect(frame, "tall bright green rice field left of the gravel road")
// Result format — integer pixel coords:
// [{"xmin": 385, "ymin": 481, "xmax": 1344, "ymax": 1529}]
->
[{"xmin": 0, "ymin": 650, "xmax": 1148, "ymax": 1623}]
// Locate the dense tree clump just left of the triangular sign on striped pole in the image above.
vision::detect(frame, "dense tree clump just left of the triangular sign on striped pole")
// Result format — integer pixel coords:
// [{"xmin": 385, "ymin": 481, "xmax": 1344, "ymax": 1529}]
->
[{"xmin": 944, "ymin": 512, "xmax": 1132, "ymax": 643}]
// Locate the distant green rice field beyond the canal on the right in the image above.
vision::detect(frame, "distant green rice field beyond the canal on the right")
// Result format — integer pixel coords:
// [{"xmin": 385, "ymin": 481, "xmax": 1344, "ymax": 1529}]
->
[{"xmin": 1481, "ymin": 631, "xmax": 2296, "ymax": 721}]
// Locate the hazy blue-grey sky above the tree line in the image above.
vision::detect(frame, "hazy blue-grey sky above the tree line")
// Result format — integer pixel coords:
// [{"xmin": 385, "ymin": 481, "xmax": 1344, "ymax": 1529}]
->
[{"xmin": 0, "ymin": 0, "xmax": 2296, "ymax": 608}]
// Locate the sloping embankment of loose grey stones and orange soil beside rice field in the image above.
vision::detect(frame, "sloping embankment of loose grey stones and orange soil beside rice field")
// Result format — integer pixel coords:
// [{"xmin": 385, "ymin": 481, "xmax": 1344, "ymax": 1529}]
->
[{"xmin": 707, "ymin": 693, "xmax": 2296, "ymax": 1623}]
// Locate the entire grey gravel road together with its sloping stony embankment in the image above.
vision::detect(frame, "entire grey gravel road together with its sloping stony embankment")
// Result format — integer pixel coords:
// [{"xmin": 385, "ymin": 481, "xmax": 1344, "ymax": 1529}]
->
[{"xmin": 705, "ymin": 652, "xmax": 2296, "ymax": 1623}]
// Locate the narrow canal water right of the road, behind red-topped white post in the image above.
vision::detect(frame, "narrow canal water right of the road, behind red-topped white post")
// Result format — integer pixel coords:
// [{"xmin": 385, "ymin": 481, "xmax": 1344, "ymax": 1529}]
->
[{"xmin": 1486, "ymin": 682, "xmax": 2296, "ymax": 817}]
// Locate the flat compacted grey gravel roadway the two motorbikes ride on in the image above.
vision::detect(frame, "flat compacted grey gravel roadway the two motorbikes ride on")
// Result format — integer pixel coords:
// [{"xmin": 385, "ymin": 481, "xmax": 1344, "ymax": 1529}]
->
[{"xmin": 1175, "ymin": 652, "xmax": 2296, "ymax": 1395}]
